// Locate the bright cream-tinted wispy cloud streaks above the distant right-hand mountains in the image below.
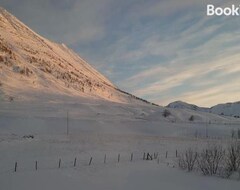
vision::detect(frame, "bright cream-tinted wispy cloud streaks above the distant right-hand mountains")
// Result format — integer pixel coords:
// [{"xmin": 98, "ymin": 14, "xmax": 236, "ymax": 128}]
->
[{"xmin": 116, "ymin": 9, "xmax": 240, "ymax": 106}]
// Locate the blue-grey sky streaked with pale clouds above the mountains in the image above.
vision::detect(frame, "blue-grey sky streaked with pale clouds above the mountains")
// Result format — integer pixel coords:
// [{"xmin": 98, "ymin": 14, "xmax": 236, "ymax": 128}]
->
[{"xmin": 0, "ymin": 0, "xmax": 240, "ymax": 107}]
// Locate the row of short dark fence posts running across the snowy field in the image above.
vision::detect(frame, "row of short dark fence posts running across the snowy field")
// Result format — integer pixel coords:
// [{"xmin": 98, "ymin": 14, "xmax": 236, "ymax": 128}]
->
[{"xmin": 0, "ymin": 150, "xmax": 178, "ymax": 174}]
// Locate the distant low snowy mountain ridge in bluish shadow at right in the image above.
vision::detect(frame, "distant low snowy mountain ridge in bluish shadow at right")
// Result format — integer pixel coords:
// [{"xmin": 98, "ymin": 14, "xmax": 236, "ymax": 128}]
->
[{"xmin": 166, "ymin": 101, "xmax": 240, "ymax": 118}]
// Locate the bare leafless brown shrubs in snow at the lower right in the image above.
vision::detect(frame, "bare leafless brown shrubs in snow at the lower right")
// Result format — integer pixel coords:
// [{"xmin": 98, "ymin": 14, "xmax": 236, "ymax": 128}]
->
[{"xmin": 178, "ymin": 141, "xmax": 240, "ymax": 178}]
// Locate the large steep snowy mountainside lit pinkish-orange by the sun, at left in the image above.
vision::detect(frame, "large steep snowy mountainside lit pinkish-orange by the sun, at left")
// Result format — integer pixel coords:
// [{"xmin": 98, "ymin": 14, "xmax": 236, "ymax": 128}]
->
[{"xmin": 0, "ymin": 8, "xmax": 152, "ymax": 103}]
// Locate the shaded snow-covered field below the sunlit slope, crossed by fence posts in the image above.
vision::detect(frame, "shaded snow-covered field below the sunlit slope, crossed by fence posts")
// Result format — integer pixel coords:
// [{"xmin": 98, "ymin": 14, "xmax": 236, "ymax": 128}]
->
[{"xmin": 0, "ymin": 94, "xmax": 240, "ymax": 190}]
